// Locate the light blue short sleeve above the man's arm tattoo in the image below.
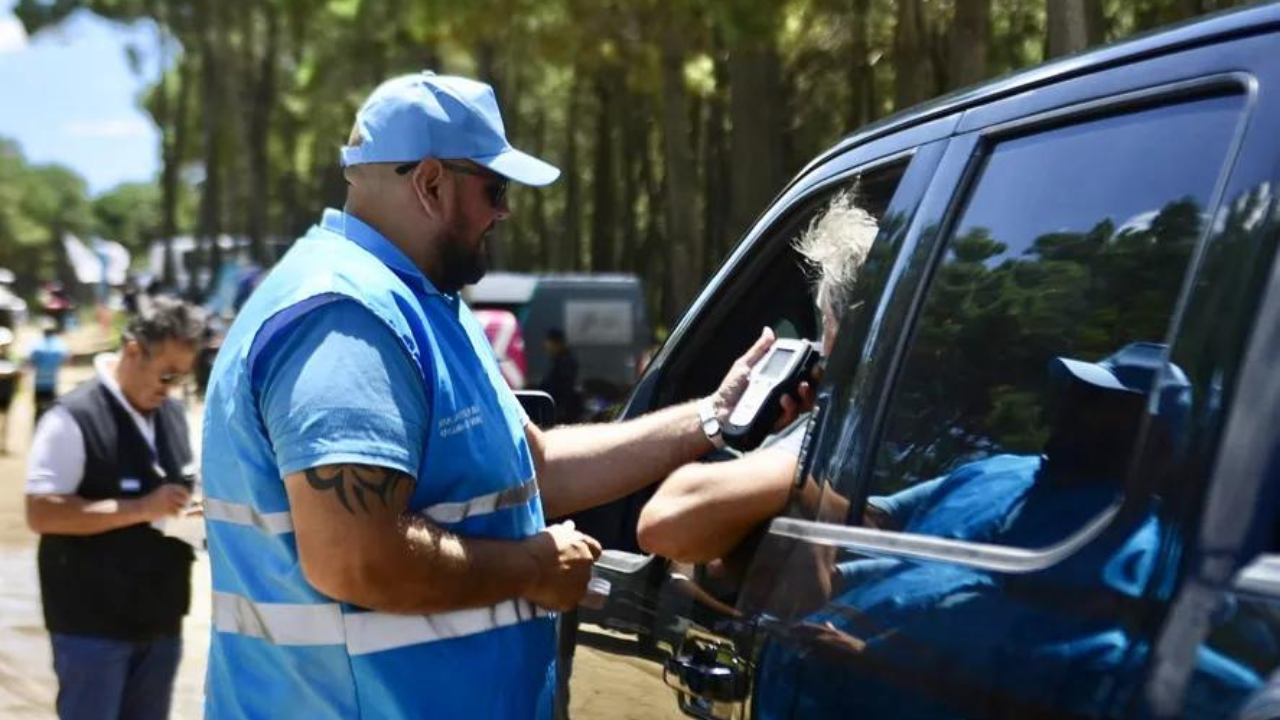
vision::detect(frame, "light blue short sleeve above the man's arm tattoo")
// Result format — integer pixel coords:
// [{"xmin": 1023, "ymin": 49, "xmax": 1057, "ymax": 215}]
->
[{"xmin": 253, "ymin": 300, "xmax": 428, "ymax": 478}]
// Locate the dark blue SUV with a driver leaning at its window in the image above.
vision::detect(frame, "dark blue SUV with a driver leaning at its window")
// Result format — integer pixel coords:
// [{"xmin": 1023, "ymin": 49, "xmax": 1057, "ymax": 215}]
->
[{"xmin": 557, "ymin": 5, "xmax": 1280, "ymax": 720}]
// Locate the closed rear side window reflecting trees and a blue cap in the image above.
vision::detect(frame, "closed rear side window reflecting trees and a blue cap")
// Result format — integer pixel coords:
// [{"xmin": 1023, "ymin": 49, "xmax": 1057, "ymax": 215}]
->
[{"xmin": 867, "ymin": 96, "xmax": 1242, "ymax": 547}]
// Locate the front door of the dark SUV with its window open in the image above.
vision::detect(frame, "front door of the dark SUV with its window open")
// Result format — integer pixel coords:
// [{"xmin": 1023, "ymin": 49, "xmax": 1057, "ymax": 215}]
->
[{"xmin": 557, "ymin": 118, "xmax": 956, "ymax": 720}]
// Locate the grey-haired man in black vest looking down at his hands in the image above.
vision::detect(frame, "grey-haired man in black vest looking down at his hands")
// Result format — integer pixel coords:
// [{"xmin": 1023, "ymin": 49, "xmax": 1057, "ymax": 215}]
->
[{"xmin": 27, "ymin": 297, "xmax": 204, "ymax": 720}]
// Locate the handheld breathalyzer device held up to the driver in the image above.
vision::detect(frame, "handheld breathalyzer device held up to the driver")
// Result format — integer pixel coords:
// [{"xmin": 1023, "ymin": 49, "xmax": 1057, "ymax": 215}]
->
[{"xmin": 721, "ymin": 338, "xmax": 822, "ymax": 451}]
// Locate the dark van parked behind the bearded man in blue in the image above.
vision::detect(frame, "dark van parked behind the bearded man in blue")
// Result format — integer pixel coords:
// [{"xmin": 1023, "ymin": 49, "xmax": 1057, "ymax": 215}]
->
[{"xmin": 463, "ymin": 273, "xmax": 652, "ymax": 415}]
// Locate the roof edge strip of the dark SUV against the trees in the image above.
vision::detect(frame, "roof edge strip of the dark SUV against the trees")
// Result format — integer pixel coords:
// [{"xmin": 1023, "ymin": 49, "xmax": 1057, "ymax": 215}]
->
[{"xmin": 796, "ymin": 3, "xmax": 1280, "ymax": 178}]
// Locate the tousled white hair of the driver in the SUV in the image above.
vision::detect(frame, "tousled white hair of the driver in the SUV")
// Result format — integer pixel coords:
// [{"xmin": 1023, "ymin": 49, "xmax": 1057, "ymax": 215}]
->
[{"xmin": 795, "ymin": 190, "xmax": 879, "ymax": 322}]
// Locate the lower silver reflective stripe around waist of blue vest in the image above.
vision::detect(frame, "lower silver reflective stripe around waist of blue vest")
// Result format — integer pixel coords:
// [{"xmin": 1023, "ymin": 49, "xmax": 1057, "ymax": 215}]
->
[{"xmin": 214, "ymin": 591, "xmax": 549, "ymax": 655}]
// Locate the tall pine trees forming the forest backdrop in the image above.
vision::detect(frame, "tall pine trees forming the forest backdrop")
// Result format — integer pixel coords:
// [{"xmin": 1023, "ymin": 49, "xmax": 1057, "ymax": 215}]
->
[{"xmin": 0, "ymin": 0, "xmax": 1249, "ymax": 322}]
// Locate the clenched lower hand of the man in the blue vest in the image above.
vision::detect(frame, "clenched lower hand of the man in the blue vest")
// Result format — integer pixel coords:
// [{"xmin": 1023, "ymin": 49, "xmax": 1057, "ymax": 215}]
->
[{"xmin": 522, "ymin": 520, "xmax": 600, "ymax": 612}]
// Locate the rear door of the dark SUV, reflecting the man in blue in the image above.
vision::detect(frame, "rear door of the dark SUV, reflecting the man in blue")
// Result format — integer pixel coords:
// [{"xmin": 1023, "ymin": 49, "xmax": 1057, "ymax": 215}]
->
[{"xmin": 737, "ymin": 25, "xmax": 1277, "ymax": 719}]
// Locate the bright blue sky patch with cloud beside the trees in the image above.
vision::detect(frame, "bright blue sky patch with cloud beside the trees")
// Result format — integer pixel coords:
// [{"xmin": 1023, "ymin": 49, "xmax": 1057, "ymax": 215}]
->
[{"xmin": 0, "ymin": 0, "xmax": 160, "ymax": 195}]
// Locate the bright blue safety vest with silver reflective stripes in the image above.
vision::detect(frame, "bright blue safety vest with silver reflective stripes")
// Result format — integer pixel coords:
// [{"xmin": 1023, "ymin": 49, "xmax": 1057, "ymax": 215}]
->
[{"xmin": 202, "ymin": 211, "xmax": 554, "ymax": 720}]
